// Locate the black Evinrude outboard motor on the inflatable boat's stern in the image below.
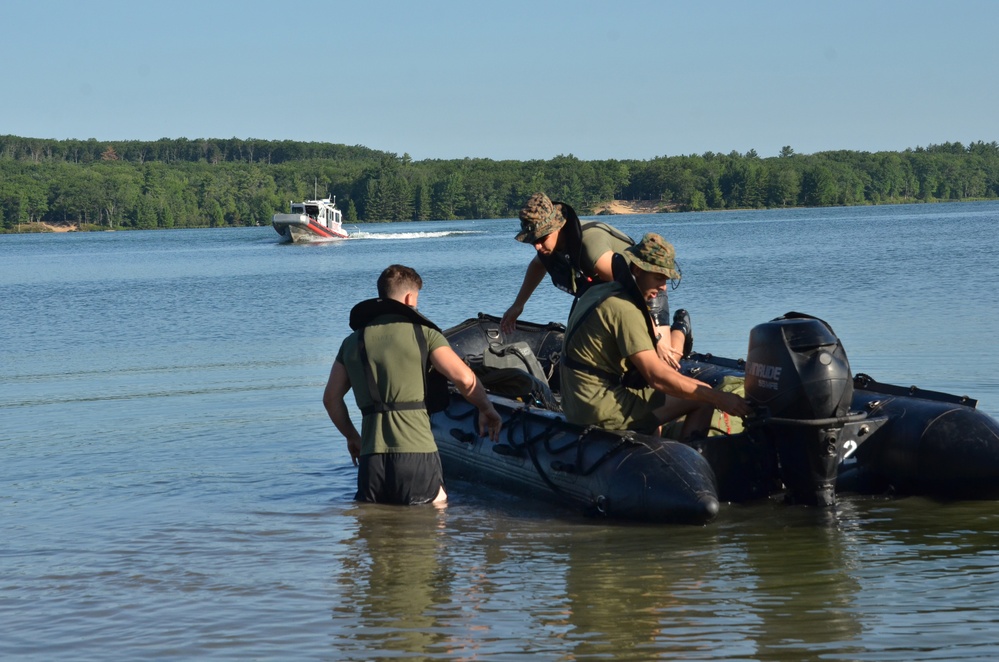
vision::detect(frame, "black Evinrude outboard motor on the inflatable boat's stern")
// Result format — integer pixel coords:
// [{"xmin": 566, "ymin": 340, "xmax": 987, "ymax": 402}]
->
[{"xmin": 746, "ymin": 312, "xmax": 853, "ymax": 506}]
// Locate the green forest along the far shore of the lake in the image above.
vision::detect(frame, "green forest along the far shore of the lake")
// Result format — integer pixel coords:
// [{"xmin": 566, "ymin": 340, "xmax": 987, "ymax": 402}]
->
[{"xmin": 0, "ymin": 136, "xmax": 999, "ymax": 231}]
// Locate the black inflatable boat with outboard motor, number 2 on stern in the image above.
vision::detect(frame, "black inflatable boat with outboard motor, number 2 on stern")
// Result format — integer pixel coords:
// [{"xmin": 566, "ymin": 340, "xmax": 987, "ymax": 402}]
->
[{"xmin": 431, "ymin": 313, "xmax": 999, "ymax": 523}]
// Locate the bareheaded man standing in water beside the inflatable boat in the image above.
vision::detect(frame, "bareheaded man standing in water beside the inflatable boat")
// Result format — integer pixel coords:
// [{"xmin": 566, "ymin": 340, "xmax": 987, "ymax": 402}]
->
[{"xmin": 323, "ymin": 264, "xmax": 502, "ymax": 504}]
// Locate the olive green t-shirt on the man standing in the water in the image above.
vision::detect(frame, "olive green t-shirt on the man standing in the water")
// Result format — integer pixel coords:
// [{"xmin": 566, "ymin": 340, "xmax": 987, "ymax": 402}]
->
[{"xmin": 336, "ymin": 315, "xmax": 448, "ymax": 455}]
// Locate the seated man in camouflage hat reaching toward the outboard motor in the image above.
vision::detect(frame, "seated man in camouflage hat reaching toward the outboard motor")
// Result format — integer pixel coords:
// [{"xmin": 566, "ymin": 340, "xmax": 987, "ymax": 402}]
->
[{"xmin": 560, "ymin": 232, "xmax": 753, "ymax": 441}]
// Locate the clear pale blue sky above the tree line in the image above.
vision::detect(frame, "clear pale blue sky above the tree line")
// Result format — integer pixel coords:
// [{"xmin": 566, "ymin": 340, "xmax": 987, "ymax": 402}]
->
[{"xmin": 0, "ymin": 0, "xmax": 999, "ymax": 160}]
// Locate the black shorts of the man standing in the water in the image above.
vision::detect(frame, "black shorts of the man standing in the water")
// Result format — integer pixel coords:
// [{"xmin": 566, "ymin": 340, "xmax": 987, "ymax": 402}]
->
[{"xmin": 354, "ymin": 452, "xmax": 444, "ymax": 505}]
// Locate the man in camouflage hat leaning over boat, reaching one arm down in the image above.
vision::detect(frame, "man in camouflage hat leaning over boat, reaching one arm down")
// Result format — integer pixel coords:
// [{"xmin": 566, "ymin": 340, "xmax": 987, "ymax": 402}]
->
[{"xmin": 500, "ymin": 193, "xmax": 693, "ymax": 368}]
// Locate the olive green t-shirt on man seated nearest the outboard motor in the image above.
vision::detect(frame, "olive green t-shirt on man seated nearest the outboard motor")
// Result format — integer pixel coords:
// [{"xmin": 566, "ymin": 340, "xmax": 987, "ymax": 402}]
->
[{"xmin": 560, "ymin": 283, "xmax": 665, "ymax": 432}]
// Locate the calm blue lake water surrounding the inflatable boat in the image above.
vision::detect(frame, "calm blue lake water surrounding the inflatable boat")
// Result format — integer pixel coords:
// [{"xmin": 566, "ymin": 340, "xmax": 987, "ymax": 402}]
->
[{"xmin": 0, "ymin": 203, "xmax": 999, "ymax": 661}]
